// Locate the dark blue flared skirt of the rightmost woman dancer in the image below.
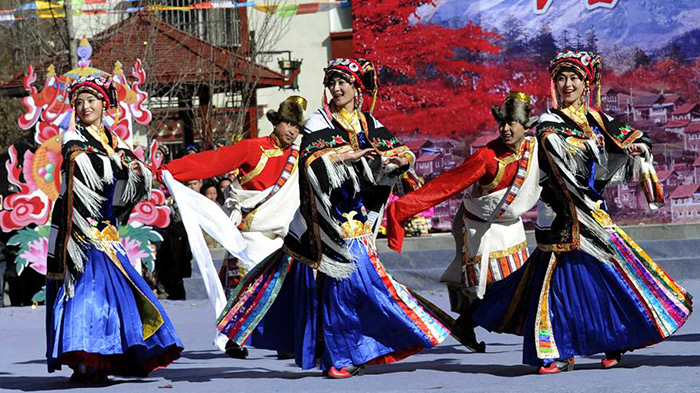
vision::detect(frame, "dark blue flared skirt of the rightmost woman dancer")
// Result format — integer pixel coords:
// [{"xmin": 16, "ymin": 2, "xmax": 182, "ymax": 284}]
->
[{"xmin": 472, "ymin": 250, "xmax": 689, "ymax": 366}]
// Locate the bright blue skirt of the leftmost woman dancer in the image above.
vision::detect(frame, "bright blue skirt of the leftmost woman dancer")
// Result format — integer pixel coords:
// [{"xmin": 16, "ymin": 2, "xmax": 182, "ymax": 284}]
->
[{"xmin": 46, "ymin": 243, "xmax": 183, "ymax": 376}]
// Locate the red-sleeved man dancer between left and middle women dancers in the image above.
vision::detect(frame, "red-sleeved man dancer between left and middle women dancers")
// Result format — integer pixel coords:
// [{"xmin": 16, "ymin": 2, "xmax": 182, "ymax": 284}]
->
[{"xmin": 161, "ymin": 96, "xmax": 306, "ymax": 358}]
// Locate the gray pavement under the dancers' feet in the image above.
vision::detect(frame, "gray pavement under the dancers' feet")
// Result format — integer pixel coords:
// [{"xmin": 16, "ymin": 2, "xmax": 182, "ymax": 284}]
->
[{"xmin": 0, "ymin": 279, "xmax": 700, "ymax": 393}]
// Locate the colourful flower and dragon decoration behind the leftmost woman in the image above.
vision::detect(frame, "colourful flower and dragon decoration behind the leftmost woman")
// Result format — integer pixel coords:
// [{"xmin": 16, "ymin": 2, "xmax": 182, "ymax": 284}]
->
[{"xmin": 0, "ymin": 37, "xmax": 170, "ymax": 294}]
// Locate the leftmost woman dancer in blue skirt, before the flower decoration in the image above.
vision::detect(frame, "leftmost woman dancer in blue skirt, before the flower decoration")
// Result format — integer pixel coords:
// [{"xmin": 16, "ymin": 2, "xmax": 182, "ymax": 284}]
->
[{"xmin": 46, "ymin": 75, "xmax": 183, "ymax": 383}]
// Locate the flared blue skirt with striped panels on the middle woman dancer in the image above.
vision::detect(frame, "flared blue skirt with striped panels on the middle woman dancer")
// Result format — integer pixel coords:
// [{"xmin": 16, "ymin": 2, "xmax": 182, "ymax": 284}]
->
[{"xmin": 219, "ymin": 236, "xmax": 449, "ymax": 370}]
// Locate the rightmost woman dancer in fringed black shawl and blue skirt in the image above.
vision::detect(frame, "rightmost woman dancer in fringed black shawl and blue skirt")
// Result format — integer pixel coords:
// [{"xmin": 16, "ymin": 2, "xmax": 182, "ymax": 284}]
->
[{"xmin": 472, "ymin": 51, "xmax": 692, "ymax": 374}]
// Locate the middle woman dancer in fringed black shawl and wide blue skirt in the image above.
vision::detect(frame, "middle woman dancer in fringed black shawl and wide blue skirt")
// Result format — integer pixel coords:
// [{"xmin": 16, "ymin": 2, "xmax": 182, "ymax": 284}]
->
[{"xmin": 219, "ymin": 59, "xmax": 449, "ymax": 378}]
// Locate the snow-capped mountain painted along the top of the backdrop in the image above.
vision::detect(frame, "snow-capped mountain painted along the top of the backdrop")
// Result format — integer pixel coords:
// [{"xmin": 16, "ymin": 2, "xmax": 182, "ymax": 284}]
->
[{"xmin": 418, "ymin": 0, "xmax": 700, "ymax": 50}]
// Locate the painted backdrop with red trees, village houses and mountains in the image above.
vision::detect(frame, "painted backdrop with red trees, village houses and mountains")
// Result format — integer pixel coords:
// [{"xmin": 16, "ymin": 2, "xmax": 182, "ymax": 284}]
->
[{"xmin": 353, "ymin": 0, "xmax": 700, "ymax": 229}]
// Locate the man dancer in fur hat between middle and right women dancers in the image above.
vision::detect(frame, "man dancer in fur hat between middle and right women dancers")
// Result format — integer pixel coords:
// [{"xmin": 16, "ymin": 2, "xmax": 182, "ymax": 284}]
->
[{"xmin": 387, "ymin": 92, "xmax": 540, "ymax": 352}]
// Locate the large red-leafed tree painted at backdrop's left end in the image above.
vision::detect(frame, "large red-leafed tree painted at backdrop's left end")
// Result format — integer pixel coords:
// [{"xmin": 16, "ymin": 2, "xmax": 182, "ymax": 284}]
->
[{"xmin": 353, "ymin": 0, "xmax": 504, "ymax": 136}]
